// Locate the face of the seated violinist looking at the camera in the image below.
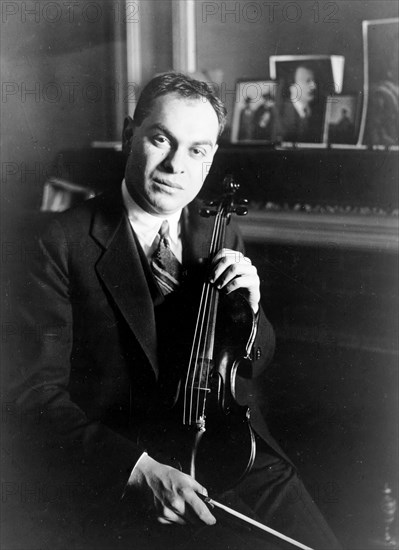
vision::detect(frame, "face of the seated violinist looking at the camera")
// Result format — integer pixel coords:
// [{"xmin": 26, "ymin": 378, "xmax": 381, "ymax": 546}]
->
[{"xmin": 125, "ymin": 93, "xmax": 219, "ymax": 216}]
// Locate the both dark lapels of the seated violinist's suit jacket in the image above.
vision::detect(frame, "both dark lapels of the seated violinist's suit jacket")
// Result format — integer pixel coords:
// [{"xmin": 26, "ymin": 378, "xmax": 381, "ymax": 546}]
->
[{"xmin": 91, "ymin": 192, "xmax": 213, "ymax": 375}]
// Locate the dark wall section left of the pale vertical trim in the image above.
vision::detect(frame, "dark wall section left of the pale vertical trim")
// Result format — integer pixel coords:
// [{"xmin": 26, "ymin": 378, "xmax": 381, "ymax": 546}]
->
[{"xmin": 1, "ymin": 1, "xmax": 123, "ymax": 216}]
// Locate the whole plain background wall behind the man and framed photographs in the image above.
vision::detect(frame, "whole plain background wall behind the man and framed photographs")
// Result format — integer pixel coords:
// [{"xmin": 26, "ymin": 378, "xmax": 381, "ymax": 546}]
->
[{"xmin": 1, "ymin": 0, "xmax": 398, "ymax": 217}]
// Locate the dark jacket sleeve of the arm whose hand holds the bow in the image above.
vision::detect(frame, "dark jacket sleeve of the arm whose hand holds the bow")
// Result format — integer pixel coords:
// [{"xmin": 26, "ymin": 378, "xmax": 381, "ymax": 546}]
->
[{"xmin": 10, "ymin": 221, "xmax": 142, "ymax": 502}]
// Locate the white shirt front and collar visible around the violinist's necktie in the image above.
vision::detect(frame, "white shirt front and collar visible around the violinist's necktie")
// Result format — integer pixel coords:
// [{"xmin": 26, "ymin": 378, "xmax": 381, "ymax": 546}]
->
[{"xmin": 122, "ymin": 180, "xmax": 183, "ymax": 263}]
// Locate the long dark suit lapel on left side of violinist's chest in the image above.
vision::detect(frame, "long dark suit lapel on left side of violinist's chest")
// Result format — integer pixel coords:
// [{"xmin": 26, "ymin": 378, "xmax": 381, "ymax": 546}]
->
[{"xmin": 91, "ymin": 194, "xmax": 158, "ymax": 374}]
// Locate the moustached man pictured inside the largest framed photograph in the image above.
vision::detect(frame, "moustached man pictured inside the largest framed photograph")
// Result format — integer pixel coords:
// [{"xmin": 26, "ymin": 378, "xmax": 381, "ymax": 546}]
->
[{"xmin": 279, "ymin": 65, "xmax": 323, "ymax": 143}]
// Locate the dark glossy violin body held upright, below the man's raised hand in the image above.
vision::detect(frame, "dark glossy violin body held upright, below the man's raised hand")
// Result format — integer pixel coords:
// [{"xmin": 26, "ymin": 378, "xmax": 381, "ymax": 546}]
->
[{"xmin": 140, "ymin": 292, "xmax": 256, "ymax": 493}]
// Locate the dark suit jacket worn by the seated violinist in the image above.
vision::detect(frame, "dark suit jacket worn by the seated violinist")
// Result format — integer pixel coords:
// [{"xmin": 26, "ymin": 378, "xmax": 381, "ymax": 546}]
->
[{"xmin": 11, "ymin": 191, "xmax": 282, "ymax": 504}]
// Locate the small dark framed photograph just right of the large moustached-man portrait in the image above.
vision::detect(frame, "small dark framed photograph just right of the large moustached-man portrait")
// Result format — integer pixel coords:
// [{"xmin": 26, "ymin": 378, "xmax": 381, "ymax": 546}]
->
[{"xmin": 323, "ymin": 94, "xmax": 359, "ymax": 145}]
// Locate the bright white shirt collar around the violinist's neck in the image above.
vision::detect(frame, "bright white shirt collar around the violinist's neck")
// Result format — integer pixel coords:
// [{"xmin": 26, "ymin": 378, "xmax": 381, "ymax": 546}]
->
[{"xmin": 122, "ymin": 179, "xmax": 181, "ymax": 247}]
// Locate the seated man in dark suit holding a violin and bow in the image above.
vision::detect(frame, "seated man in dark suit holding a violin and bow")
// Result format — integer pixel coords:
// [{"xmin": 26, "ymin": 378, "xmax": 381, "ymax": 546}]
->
[{"xmin": 9, "ymin": 73, "xmax": 339, "ymax": 549}]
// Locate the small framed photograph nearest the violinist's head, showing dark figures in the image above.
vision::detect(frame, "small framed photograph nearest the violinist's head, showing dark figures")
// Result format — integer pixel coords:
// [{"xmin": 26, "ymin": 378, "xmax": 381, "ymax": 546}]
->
[{"xmin": 231, "ymin": 80, "xmax": 278, "ymax": 143}]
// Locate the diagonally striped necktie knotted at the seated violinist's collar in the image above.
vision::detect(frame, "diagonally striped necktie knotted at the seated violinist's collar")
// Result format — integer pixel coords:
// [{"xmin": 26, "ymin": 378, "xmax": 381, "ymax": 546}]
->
[{"xmin": 150, "ymin": 220, "xmax": 181, "ymax": 295}]
